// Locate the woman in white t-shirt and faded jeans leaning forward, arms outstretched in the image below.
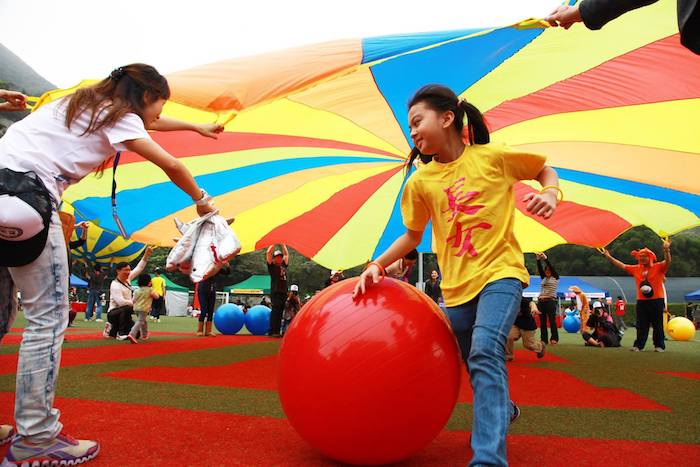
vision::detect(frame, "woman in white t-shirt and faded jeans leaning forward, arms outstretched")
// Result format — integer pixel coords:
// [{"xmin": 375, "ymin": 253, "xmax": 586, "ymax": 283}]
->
[{"xmin": 0, "ymin": 64, "xmax": 223, "ymax": 465}]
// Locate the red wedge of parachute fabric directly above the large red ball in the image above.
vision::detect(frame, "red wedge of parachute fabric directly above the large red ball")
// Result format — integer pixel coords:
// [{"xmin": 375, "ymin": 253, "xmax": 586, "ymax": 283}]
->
[{"xmin": 255, "ymin": 166, "xmax": 403, "ymax": 258}]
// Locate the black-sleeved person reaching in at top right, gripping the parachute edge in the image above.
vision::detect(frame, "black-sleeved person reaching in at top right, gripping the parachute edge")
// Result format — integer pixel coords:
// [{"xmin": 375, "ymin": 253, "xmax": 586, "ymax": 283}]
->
[{"xmin": 545, "ymin": 0, "xmax": 700, "ymax": 55}]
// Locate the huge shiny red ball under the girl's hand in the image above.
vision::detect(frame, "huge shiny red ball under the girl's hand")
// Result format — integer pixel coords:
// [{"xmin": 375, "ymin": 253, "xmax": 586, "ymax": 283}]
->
[{"xmin": 279, "ymin": 278, "xmax": 461, "ymax": 465}]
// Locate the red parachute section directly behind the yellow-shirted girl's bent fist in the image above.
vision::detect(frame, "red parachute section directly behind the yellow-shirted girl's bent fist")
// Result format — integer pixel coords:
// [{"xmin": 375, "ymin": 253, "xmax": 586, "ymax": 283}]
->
[{"xmin": 513, "ymin": 183, "xmax": 632, "ymax": 247}]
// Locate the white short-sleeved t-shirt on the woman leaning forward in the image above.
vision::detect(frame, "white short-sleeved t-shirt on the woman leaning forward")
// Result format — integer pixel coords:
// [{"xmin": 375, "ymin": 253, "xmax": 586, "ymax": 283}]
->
[{"xmin": 0, "ymin": 99, "xmax": 150, "ymax": 202}]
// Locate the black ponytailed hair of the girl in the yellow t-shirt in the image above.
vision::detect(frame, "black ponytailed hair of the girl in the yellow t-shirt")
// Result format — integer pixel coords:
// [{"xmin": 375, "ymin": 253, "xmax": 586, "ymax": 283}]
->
[{"xmin": 406, "ymin": 84, "xmax": 491, "ymax": 173}]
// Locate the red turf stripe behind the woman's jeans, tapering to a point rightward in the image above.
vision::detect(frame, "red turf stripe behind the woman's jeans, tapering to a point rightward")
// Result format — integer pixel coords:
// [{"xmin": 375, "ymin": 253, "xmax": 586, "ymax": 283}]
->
[{"xmin": 0, "ymin": 335, "xmax": 271, "ymax": 375}]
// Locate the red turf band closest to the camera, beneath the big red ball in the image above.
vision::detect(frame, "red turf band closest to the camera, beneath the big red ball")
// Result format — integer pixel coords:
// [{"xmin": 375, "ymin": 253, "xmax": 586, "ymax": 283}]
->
[{"xmin": 0, "ymin": 393, "xmax": 700, "ymax": 467}]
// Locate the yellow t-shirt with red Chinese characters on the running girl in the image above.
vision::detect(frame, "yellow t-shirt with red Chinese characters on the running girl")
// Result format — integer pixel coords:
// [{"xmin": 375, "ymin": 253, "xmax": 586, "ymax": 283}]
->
[{"xmin": 401, "ymin": 143, "xmax": 546, "ymax": 306}]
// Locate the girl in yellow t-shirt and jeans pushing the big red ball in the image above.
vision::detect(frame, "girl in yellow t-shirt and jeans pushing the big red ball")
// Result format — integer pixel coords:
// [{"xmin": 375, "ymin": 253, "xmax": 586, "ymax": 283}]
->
[{"xmin": 355, "ymin": 85, "xmax": 561, "ymax": 465}]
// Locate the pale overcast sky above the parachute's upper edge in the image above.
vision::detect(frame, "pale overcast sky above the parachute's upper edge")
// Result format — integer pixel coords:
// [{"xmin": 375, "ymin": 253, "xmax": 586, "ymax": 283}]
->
[{"xmin": 0, "ymin": 0, "xmax": 560, "ymax": 87}]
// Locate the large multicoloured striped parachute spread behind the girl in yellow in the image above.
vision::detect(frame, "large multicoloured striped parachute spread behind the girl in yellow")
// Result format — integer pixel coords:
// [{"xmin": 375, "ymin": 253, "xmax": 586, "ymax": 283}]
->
[{"xmin": 39, "ymin": 0, "xmax": 700, "ymax": 269}]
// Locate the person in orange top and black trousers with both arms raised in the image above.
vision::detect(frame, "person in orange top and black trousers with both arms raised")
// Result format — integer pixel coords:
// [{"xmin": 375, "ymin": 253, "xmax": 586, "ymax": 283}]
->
[{"xmin": 603, "ymin": 240, "xmax": 671, "ymax": 352}]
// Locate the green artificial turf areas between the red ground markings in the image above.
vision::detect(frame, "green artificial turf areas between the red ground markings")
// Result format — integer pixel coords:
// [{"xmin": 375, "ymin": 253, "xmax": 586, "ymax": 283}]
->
[{"xmin": 0, "ymin": 317, "xmax": 700, "ymax": 444}]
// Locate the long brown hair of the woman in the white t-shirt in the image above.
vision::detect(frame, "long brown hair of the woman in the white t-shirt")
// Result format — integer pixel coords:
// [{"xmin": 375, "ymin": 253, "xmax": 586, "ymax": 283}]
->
[{"xmin": 65, "ymin": 63, "xmax": 170, "ymax": 176}]
